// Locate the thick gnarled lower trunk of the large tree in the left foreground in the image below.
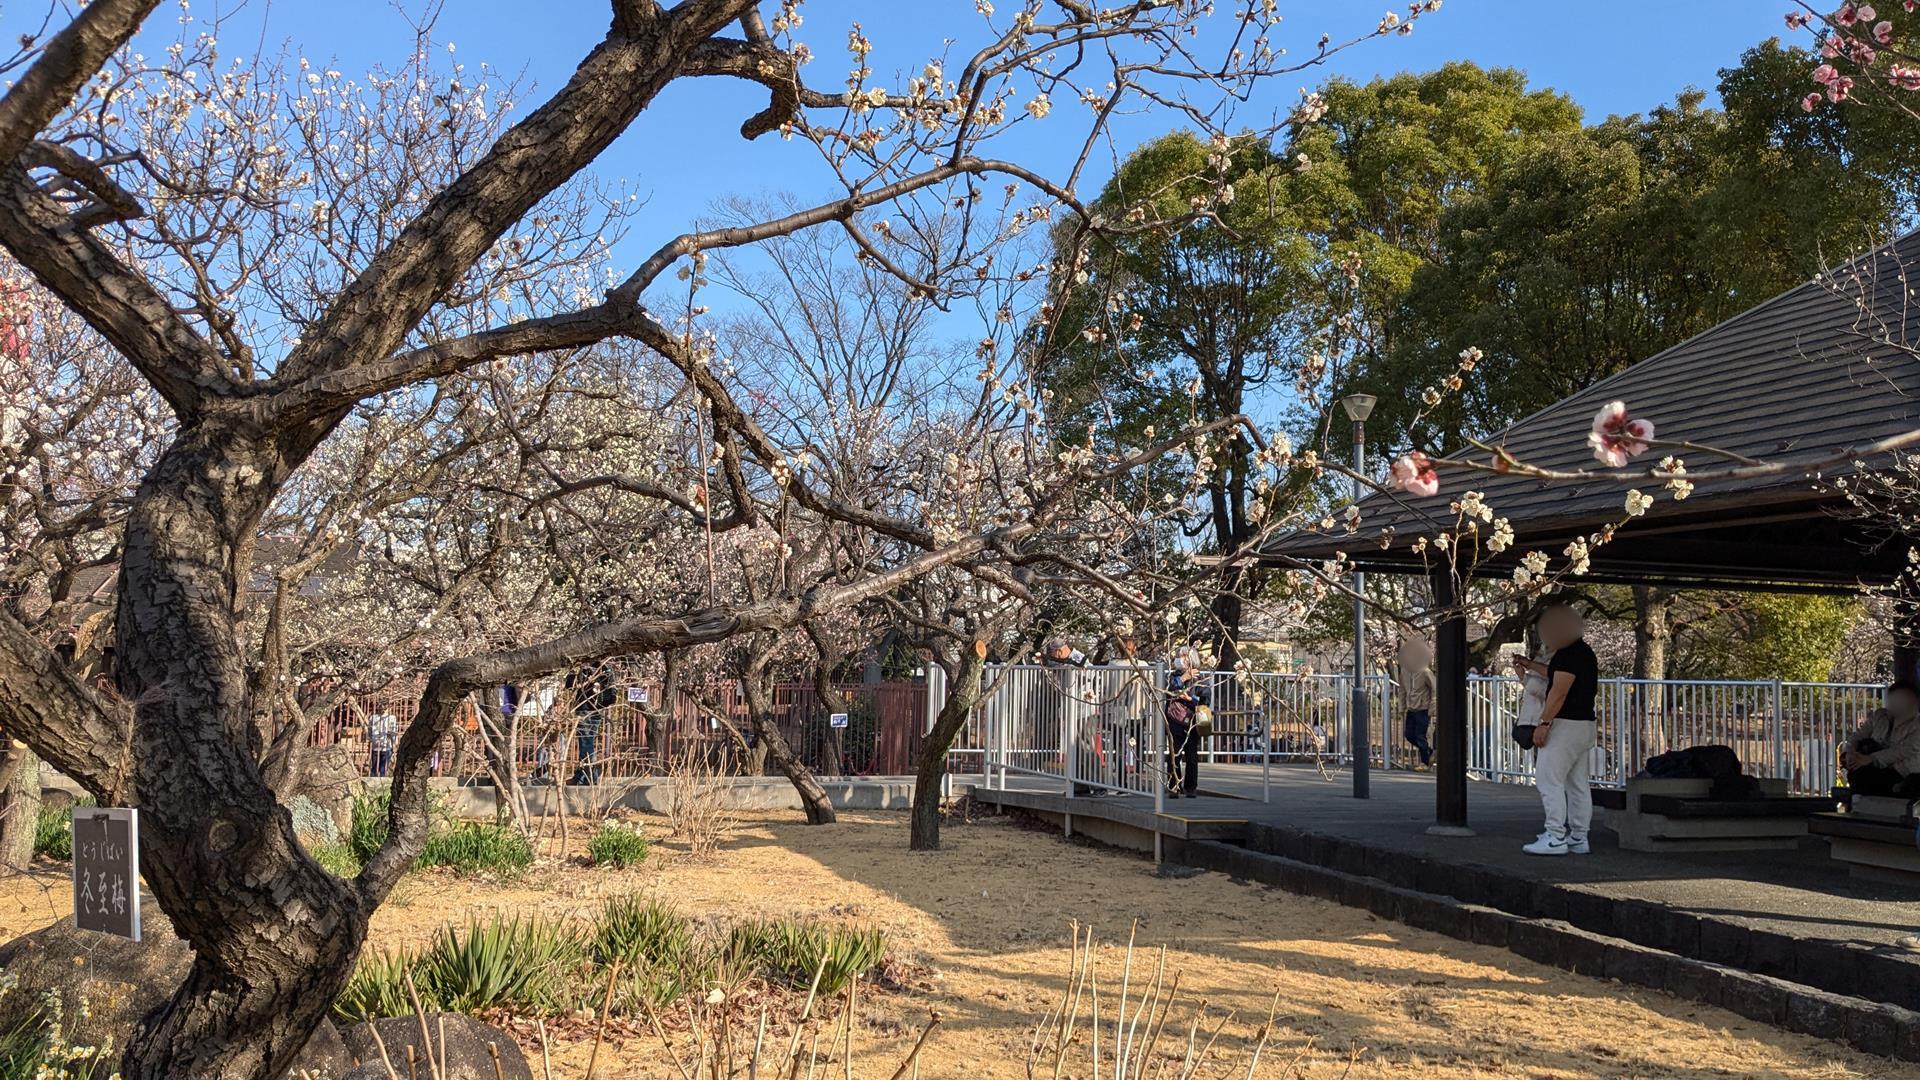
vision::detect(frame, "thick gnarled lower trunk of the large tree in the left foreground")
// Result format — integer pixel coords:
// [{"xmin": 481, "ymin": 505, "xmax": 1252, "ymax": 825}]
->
[{"xmin": 115, "ymin": 425, "xmax": 369, "ymax": 1080}]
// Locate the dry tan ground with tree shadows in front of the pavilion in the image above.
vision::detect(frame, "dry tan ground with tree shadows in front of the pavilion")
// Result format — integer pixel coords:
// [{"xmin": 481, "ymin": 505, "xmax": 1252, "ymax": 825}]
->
[{"xmin": 0, "ymin": 813, "xmax": 1920, "ymax": 1080}]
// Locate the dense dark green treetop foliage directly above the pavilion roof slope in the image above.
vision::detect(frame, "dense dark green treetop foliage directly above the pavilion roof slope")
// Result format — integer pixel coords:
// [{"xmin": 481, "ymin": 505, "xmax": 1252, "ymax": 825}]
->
[{"xmin": 1359, "ymin": 52, "xmax": 1920, "ymax": 450}]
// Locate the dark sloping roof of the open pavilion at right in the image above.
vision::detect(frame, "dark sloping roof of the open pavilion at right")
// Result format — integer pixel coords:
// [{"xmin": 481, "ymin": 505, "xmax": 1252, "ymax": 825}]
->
[{"xmin": 1269, "ymin": 233, "xmax": 1920, "ymax": 588}]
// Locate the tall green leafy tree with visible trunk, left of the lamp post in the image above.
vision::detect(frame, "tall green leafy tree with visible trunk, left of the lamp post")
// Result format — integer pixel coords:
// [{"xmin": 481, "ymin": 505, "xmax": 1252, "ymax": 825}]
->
[{"xmin": 1041, "ymin": 133, "xmax": 1325, "ymax": 663}]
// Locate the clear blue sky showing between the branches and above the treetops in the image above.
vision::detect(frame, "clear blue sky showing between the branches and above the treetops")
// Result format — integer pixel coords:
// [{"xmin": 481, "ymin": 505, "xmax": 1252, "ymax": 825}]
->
[{"xmin": 48, "ymin": 0, "xmax": 1786, "ymax": 278}]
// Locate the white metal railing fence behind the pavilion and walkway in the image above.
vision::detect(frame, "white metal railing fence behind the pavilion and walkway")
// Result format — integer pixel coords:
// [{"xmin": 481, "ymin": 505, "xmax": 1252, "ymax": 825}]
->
[{"xmin": 977, "ymin": 665, "xmax": 1882, "ymax": 794}]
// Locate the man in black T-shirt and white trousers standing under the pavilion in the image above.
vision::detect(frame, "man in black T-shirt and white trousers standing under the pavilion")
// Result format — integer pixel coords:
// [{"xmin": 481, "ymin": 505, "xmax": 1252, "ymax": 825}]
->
[{"xmin": 1515, "ymin": 603, "xmax": 1599, "ymax": 855}]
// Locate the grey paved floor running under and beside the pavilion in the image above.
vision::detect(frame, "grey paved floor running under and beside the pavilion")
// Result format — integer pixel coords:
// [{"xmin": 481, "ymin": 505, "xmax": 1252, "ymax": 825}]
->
[{"xmin": 983, "ymin": 765, "xmax": 1920, "ymax": 945}]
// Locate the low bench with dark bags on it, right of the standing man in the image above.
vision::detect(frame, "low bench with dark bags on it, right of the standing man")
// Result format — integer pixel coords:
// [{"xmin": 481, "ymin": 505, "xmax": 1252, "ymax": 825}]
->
[{"xmin": 1594, "ymin": 776, "xmax": 1834, "ymax": 851}]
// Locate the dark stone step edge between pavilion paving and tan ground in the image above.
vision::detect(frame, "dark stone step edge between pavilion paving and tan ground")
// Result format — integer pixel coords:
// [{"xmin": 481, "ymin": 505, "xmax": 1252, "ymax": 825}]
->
[{"xmin": 1167, "ymin": 838, "xmax": 1920, "ymax": 1061}]
